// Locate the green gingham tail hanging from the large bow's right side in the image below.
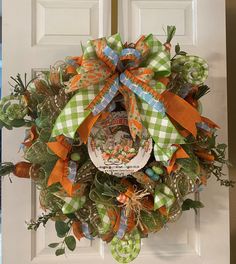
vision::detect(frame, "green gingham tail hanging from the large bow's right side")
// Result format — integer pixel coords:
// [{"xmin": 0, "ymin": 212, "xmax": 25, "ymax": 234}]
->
[{"xmin": 137, "ymin": 100, "xmax": 184, "ymax": 161}]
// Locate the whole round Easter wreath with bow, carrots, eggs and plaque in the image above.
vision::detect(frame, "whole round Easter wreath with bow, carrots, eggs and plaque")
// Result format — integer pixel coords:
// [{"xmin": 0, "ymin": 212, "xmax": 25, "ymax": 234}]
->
[{"xmin": 0, "ymin": 26, "xmax": 233, "ymax": 263}]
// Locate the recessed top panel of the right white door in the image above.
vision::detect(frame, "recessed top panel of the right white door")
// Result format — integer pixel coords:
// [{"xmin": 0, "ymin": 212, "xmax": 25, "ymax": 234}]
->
[{"xmin": 120, "ymin": 0, "xmax": 197, "ymax": 44}]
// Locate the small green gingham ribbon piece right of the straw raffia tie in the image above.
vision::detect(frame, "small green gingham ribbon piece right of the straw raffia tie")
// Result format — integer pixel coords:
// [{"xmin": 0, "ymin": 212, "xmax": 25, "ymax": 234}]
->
[{"xmin": 154, "ymin": 183, "xmax": 175, "ymax": 211}]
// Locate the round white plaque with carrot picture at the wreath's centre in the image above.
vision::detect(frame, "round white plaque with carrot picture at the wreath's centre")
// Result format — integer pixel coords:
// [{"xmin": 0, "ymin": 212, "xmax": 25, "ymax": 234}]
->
[{"xmin": 88, "ymin": 111, "xmax": 152, "ymax": 177}]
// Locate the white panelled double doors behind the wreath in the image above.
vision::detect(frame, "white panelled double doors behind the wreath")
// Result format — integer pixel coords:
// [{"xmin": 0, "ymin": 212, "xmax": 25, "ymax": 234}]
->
[{"xmin": 2, "ymin": 0, "xmax": 229, "ymax": 264}]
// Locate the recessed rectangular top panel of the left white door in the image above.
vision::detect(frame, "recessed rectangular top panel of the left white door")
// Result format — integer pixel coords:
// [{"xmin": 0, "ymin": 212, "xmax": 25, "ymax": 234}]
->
[{"xmin": 32, "ymin": 0, "xmax": 104, "ymax": 45}]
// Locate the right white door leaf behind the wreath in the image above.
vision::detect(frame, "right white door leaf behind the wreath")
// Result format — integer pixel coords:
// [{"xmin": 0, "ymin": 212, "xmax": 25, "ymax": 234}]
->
[{"xmin": 119, "ymin": 0, "xmax": 229, "ymax": 264}]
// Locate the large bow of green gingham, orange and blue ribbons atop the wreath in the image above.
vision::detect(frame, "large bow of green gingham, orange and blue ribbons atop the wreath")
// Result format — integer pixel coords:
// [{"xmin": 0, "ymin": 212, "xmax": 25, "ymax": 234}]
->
[{"xmin": 52, "ymin": 34, "xmax": 205, "ymax": 160}]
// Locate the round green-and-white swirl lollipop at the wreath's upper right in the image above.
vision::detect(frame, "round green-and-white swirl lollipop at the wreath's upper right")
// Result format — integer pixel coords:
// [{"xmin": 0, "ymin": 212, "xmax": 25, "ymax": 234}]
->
[{"xmin": 172, "ymin": 56, "xmax": 208, "ymax": 85}]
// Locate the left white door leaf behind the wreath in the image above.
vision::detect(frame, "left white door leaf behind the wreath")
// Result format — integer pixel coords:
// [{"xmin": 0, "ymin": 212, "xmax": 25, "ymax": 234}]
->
[{"xmin": 2, "ymin": 0, "xmax": 111, "ymax": 264}]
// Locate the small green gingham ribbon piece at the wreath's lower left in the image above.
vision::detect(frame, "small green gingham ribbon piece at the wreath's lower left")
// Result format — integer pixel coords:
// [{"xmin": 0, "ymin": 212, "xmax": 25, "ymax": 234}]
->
[{"xmin": 54, "ymin": 193, "xmax": 86, "ymax": 214}]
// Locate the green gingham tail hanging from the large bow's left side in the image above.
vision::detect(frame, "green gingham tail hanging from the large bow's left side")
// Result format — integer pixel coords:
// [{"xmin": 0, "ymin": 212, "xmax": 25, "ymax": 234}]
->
[{"xmin": 52, "ymin": 85, "xmax": 102, "ymax": 138}]
